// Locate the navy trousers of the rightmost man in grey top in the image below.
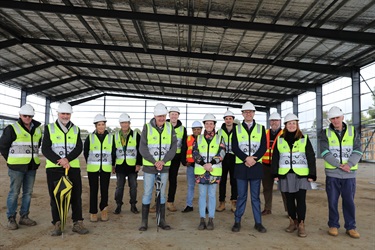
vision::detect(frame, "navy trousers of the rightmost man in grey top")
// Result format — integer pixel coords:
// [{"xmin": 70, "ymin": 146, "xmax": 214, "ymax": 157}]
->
[{"xmin": 326, "ymin": 176, "xmax": 356, "ymax": 230}]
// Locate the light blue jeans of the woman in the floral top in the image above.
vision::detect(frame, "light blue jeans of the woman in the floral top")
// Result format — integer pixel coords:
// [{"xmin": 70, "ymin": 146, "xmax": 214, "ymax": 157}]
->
[{"xmin": 198, "ymin": 183, "xmax": 217, "ymax": 218}]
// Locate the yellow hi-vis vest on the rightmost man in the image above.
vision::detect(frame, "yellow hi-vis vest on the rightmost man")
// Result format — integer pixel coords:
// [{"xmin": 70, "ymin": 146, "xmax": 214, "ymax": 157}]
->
[{"xmin": 324, "ymin": 125, "xmax": 358, "ymax": 170}]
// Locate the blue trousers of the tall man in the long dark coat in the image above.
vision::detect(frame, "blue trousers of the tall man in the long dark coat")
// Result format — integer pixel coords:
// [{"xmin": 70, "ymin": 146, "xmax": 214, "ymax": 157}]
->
[{"xmin": 234, "ymin": 179, "xmax": 262, "ymax": 224}]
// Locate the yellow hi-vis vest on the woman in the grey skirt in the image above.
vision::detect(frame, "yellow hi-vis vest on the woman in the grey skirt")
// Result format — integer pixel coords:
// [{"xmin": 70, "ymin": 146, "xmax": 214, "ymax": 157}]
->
[{"xmin": 277, "ymin": 135, "xmax": 309, "ymax": 176}]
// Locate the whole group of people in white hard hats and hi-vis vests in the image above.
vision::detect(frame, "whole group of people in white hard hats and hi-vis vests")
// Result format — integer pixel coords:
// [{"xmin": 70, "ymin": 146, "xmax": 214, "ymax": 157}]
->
[{"xmin": 0, "ymin": 102, "xmax": 362, "ymax": 238}]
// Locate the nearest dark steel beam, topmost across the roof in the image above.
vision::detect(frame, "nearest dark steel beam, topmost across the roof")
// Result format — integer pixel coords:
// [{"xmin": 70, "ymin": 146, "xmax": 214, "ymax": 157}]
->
[{"xmin": 0, "ymin": 1, "xmax": 375, "ymax": 45}]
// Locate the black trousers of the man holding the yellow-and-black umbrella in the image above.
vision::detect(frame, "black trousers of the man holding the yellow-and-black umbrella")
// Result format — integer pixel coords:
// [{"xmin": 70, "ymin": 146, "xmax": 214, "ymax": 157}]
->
[{"xmin": 46, "ymin": 168, "xmax": 83, "ymax": 224}]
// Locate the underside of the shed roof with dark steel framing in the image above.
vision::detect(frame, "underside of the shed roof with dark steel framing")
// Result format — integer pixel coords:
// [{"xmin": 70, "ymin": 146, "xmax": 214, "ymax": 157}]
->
[{"xmin": 0, "ymin": 0, "xmax": 375, "ymax": 111}]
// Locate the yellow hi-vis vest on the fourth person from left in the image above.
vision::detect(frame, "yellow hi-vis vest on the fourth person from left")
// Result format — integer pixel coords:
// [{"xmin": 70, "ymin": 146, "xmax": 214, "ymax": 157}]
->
[{"xmin": 115, "ymin": 131, "xmax": 137, "ymax": 166}]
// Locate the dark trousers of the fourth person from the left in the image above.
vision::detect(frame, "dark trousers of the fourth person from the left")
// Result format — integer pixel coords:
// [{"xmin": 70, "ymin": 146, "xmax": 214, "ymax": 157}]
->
[{"xmin": 115, "ymin": 172, "xmax": 138, "ymax": 205}]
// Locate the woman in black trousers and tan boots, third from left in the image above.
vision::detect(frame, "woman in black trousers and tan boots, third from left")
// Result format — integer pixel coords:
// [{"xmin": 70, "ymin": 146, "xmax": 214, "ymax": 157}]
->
[{"xmin": 83, "ymin": 114, "xmax": 116, "ymax": 222}]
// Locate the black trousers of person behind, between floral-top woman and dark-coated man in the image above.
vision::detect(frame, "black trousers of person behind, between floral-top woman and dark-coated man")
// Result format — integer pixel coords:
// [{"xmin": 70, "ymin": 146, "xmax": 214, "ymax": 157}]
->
[{"xmin": 219, "ymin": 154, "xmax": 238, "ymax": 201}]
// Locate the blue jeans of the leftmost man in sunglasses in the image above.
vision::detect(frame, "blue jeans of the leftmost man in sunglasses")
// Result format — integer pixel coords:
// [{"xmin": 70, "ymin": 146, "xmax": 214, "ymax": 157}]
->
[{"xmin": 7, "ymin": 168, "xmax": 36, "ymax": 218}]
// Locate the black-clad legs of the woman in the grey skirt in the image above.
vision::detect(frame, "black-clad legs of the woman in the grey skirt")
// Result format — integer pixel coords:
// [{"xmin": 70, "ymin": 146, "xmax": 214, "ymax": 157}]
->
[{"xmin": 284, "ymin": 189, "xmax": 306, "ymax": 223}]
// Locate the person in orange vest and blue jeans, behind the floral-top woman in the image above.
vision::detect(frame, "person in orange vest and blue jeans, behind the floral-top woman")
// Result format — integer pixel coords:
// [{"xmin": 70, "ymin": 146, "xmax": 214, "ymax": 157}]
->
[{"xmin": 181, "ymin": 121, "xmax": 203, "ymax": 213}]
